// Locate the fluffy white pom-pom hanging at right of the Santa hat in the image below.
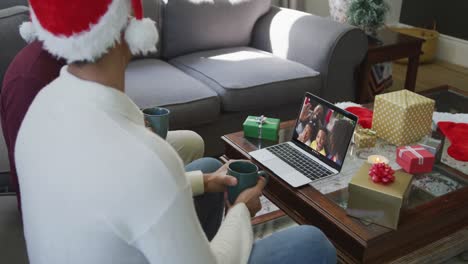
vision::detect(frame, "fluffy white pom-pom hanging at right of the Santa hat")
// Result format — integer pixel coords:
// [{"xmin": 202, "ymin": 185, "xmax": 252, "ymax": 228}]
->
[{"xmin": 125, "ymin": 18, "xmax": 159, "ymax": 55}]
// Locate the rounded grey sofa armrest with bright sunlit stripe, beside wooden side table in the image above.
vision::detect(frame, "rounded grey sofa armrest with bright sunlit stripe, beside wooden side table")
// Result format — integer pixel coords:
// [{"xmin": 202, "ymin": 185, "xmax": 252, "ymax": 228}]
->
[{"xmin": 251, "ymin": 6, "xmax": 368, "ymax": 102}]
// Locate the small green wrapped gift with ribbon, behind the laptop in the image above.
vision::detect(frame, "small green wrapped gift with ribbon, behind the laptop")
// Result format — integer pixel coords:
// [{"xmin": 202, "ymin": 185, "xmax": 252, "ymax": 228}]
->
[{"xmin": 243, "ymin": 116, "xmax": 280, "ymax": 141}]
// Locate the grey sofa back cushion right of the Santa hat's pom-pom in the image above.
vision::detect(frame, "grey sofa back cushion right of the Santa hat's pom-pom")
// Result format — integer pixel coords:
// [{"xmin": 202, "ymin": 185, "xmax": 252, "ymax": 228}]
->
[{"xmin": 162, "ymin": 0, "xmax": 271, "ymax": 59}]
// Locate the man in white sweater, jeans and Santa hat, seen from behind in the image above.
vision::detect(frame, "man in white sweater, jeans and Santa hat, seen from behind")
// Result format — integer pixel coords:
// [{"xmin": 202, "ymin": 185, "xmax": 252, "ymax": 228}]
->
[{"xmin": 15, "ymin": 0, "xmax": 336, "ymax": 264}]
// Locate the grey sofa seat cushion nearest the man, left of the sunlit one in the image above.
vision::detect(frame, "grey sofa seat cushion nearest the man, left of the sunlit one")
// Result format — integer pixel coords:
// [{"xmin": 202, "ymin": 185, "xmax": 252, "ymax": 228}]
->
[{"xmin": 125, "ymin": 59, "xmax": 220, "ymax": 129}]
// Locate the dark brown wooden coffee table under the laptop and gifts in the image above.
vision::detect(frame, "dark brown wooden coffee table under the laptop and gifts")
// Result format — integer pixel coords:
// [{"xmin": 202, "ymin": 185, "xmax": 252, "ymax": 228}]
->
[{"xmin": 222, "ymin": 112, "xmax": 468, "ymax": 263}]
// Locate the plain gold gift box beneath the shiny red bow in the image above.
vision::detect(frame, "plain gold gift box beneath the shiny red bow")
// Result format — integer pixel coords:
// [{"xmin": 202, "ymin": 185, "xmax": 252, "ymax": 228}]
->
[{"xmin": 346, "ymin": 163, "xmax": 413, "ymax": 229}]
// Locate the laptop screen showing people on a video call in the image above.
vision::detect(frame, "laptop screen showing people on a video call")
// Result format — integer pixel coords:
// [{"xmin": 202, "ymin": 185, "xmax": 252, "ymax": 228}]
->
[{"xmin": 293, "ymin": 93, "xmax": 357, "ymax": 171}]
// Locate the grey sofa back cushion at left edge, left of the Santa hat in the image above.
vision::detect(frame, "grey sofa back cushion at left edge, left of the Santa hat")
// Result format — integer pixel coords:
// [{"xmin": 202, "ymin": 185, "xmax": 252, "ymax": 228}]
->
[{"xmin": 0, "ymin": 6, "xmax": 29, "ymax": 87}]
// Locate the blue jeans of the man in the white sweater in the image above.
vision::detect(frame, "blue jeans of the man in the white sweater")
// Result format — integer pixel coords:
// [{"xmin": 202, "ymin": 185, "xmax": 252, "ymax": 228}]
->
[{"xmin": 185, "ymin": 158, "xmax": 337, "ymax": 264}]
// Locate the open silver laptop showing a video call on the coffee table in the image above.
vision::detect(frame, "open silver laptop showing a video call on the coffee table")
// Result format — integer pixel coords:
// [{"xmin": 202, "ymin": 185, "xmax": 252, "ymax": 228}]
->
[{"xmin": 249, "ymin": 93, "xmax": 357, "ymax": 187}]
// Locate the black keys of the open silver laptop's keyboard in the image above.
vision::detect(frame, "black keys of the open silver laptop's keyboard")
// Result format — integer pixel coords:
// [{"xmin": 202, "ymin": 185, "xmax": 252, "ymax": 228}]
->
[{"xmin": 267, "ymin": 144, "xmax": 333, "ymax": 180}]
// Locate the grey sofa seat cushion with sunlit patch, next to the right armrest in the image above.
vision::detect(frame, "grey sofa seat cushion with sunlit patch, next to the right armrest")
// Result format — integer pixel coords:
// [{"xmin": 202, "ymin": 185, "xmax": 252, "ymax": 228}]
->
[{"xmin": 170, "ymin": 47, "xmax": 321, "ymax": 111}]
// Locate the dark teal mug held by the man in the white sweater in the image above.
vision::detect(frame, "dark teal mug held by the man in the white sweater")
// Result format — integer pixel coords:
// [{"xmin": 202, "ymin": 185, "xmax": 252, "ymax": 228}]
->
[{"xmin": 227, "ymin": 161, "xmax": 268, "ymax": 204}]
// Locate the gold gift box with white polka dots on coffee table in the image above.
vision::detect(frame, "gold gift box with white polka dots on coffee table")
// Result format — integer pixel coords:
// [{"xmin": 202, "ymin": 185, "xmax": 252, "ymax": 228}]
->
[{"xmin": 372, "ymin": 90, "xmax": 435, "ymax": 146}]
